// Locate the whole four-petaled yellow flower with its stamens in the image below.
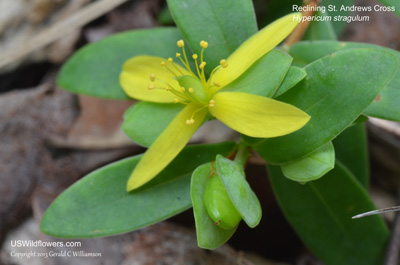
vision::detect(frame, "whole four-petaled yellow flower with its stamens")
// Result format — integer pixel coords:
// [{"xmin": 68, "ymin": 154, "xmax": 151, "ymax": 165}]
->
[{"xmin": 120, "ymin": 13, "xmax": 309, "ymax": 191}]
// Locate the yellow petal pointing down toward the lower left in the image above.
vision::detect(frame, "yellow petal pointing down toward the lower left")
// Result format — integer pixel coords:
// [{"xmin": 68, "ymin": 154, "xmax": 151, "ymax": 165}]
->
[{"xmin": 127, "ymin": 104, "xmax": 207, "ymax": 191}]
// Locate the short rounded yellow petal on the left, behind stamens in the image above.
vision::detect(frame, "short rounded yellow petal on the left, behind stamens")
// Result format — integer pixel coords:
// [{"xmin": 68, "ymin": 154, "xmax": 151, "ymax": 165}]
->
[{"xmin": 119, "ymin": 56, "xmax": 190, "ymax": 103}]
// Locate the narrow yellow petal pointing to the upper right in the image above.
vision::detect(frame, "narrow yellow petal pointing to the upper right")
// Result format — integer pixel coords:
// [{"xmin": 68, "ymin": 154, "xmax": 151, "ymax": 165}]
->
[{"xmin": 212, "ymin": 13, "xmax": 301, "ymax": 89}]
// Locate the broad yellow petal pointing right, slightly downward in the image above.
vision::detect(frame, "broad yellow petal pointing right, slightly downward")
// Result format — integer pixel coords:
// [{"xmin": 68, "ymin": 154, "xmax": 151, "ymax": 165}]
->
[{"xmin": 209, "ymin": 92, "xmax": 310, "ymax": 138}]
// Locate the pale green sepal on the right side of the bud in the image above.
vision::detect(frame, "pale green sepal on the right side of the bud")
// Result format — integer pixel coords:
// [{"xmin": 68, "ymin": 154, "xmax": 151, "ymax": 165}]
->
[{"xmin": 216, "ymin": 155, "xmax": 262, "ymax": 228}]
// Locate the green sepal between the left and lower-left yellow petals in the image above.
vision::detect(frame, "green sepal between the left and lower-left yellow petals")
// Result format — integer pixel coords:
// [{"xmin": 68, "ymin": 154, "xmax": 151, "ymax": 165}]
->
[{"xmin": 122, "ymin": 102, "xmax": 184, "ymax": 147}]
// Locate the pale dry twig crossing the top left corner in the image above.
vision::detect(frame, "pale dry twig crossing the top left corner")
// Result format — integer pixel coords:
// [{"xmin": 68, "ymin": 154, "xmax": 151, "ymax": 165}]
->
[{"xmin": 0, "ymin": 0, "xmax": 128, "ymax": 68}]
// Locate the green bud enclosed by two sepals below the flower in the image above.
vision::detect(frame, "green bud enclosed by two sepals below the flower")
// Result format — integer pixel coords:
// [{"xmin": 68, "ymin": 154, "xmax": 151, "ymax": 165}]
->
[{"xmin": 190, "ymin": 155, "xmax": 261, "ymax": 249}]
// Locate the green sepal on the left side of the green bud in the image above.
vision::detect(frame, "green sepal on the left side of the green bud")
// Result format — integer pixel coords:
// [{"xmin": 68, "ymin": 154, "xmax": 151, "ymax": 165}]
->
[{"xmin": 190, "ymin": 163, "xmax": 236, "ymax": 249}]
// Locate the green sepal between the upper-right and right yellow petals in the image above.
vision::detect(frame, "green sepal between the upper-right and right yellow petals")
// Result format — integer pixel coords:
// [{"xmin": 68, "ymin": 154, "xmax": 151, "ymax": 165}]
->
[{"xmin": 221, "ymin": 50, "xmax": 293, "ymax": 97}]
